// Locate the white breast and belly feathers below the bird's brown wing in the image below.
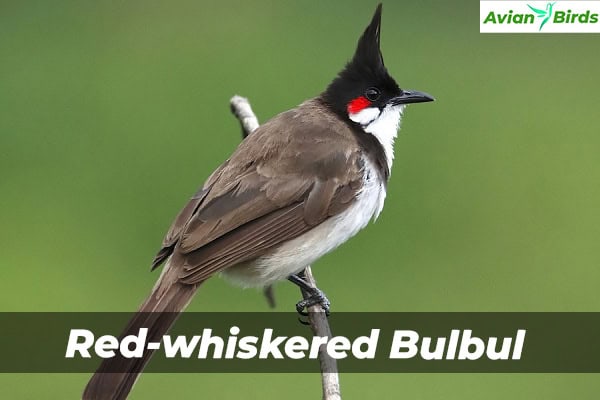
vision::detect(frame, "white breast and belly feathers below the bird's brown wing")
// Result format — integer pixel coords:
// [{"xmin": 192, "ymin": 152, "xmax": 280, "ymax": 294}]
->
[{"xmin": 222, "ymin": 159, "xmax": 386, "ymax": 287}]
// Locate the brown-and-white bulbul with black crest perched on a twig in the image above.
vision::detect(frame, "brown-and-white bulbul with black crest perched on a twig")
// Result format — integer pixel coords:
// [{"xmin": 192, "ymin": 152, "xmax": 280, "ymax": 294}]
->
[{"xmin": 83, "ymin": 4, "xmax": 434, "ymax": 400}]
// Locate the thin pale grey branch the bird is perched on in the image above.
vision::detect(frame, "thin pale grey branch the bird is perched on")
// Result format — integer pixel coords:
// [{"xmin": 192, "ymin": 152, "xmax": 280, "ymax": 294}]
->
[{"xmin": 229, "ymin": 95, "xmax": 342, "ymax": 400}]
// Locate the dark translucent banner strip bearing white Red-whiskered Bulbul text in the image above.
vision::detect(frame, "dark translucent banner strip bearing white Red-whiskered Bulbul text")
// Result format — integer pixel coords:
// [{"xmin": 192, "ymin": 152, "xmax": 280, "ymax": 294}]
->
[{"xmin": 0, "ymin": 313, "xmax": 600, "ymax": 373}]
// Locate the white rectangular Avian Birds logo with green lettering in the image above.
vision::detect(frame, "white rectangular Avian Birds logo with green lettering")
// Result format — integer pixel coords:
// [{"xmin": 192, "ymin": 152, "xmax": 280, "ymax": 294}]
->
[{"xmin": 479, "ymin": 0, "xmax": 600, "ymax": 33}]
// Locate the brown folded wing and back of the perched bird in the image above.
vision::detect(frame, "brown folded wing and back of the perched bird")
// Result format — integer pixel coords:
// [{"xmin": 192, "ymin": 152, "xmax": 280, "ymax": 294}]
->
[{"xmin": 156, "ymin": 98, "xmax": 362, "ymax": 284}]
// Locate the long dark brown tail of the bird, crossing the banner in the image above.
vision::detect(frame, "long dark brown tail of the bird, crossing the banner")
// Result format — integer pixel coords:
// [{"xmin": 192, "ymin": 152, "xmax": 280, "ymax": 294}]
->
[{"xmin": 82, "ymin": 260, "xmax": 199, "ymax": 400}]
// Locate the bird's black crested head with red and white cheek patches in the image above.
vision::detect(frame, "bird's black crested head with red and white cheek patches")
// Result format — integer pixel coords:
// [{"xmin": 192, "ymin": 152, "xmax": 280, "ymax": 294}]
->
[{"xmin": 322, "ymin": 4, "xmax": 433, "ymax": 133}]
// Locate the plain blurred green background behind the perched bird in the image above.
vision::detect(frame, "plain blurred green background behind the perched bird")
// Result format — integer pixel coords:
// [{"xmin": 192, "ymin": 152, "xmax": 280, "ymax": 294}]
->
[{"xmin": 0, "ymin": 0, "xmax": 600, "ymax": 399}]
